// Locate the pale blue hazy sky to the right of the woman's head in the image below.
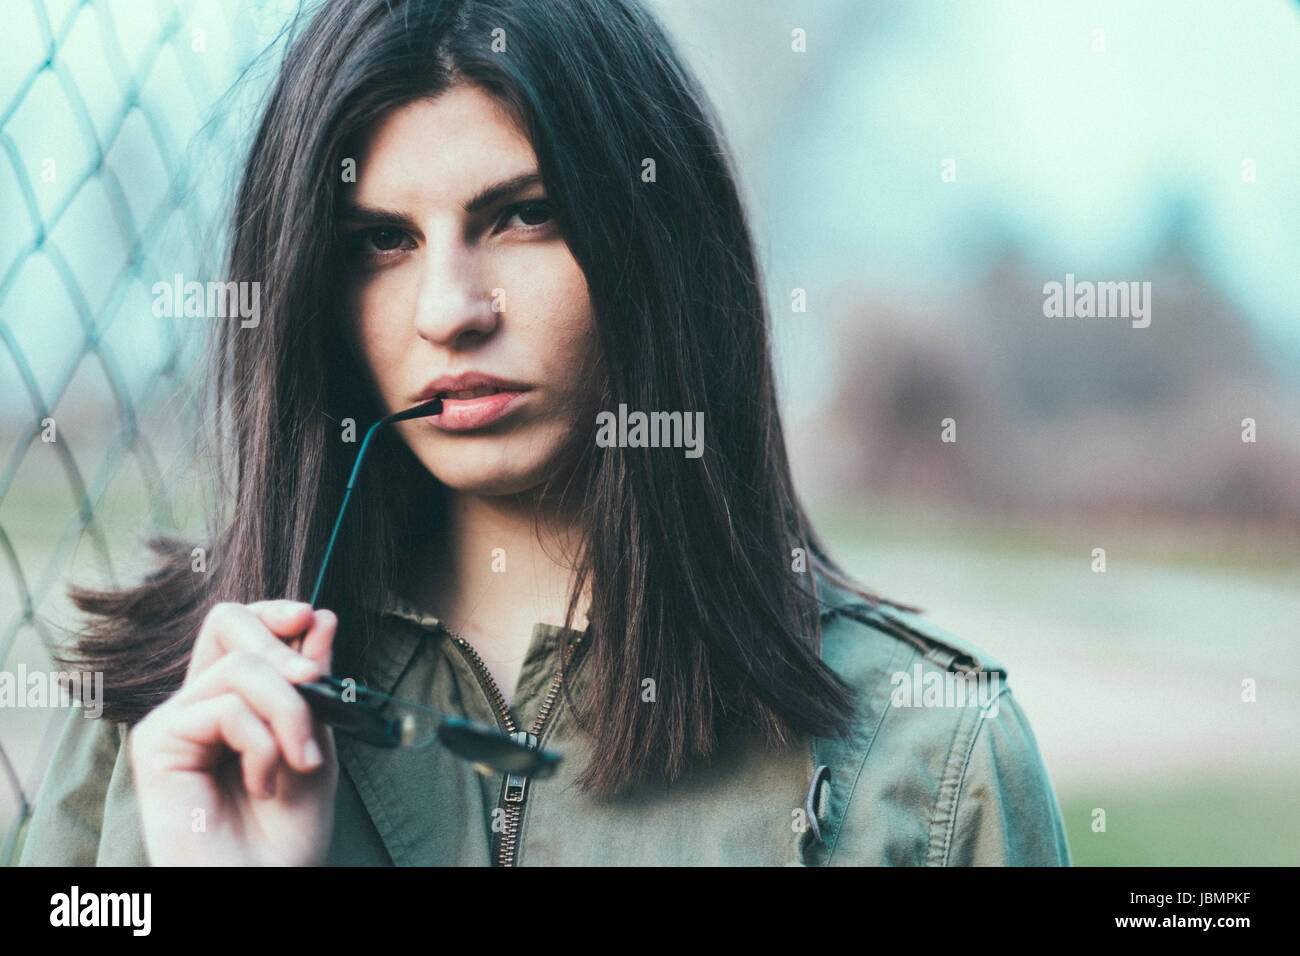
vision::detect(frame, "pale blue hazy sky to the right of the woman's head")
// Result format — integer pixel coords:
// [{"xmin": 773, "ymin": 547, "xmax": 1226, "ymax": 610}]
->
[{"xmin": 658, "ymin": 0, "xmax": 1300, "ymax": 405}]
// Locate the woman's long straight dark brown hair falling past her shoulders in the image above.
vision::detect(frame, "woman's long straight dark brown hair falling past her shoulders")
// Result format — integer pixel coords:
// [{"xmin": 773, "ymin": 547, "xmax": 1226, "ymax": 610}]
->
[{"xmin": 63, "ymin": 0, "xmax": 904, "ymax": 792}]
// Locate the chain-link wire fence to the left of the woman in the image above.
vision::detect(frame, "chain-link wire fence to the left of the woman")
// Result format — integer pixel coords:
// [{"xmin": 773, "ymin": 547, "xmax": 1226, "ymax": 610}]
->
[{"xmin": 0, "ymin": 0, "xmax": 298, "ymax": 864}]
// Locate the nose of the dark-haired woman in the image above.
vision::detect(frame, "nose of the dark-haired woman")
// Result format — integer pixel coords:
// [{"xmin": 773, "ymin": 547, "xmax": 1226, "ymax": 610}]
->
[{"xmin": 415, "ymin": 235, "xmax": 501, "ymax": 347}]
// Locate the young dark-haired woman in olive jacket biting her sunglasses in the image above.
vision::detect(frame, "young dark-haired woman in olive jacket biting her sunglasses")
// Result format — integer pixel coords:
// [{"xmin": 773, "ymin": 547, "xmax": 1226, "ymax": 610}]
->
[{"xmin": 23, "ymin": 0, "xmax": 1069, "ymax": 865}]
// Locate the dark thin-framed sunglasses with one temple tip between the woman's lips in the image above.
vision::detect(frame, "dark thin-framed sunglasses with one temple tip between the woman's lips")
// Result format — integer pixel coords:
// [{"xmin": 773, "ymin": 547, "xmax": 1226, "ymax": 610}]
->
[{"xmin": 296, "ymin": 398, "xmax": 560, "ymax": 777}]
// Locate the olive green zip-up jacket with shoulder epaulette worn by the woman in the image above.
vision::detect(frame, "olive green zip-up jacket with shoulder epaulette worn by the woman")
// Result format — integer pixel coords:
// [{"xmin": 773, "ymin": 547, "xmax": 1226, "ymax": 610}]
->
[{"xmin": 21, "ymin": 581, "xmax": 1070, "ymax": 866}]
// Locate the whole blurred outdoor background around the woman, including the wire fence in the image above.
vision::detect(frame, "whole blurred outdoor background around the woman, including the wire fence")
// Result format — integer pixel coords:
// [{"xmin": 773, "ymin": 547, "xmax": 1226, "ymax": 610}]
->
[{"xmin": 0, "ymin": 0, "xmax": 1300, "ymax": 865}]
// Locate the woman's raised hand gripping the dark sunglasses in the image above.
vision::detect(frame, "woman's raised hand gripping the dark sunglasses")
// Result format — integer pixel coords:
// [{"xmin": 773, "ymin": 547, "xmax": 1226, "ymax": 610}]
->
[{"xmin": 129, "ymin": 601, "xmax": 338, "ymax": 866}]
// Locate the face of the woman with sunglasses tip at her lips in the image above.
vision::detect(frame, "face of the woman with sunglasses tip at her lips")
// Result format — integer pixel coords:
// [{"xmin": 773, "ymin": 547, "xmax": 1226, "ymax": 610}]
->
[{"xmin": 341, "ymin": 86, "xmax": 598, "ymax": 496}]
